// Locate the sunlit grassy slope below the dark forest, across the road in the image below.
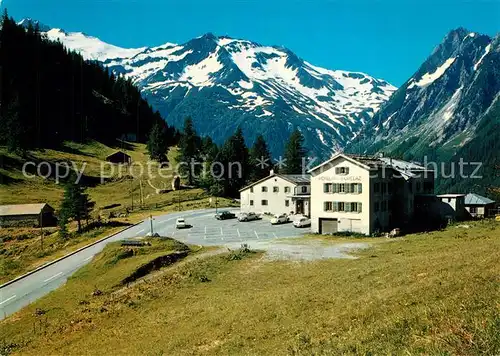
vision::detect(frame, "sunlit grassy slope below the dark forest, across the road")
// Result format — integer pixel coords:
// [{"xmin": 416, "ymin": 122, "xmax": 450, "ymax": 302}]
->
[{"xmin": 0, "ymin": 142, "xmax": 203, "ymax": 210}]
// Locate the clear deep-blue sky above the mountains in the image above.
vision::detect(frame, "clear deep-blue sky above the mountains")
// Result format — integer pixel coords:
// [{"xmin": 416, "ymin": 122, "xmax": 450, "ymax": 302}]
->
[{"xmin": 0, "ymin": 0, "xmax": 500, "ymax": 85}]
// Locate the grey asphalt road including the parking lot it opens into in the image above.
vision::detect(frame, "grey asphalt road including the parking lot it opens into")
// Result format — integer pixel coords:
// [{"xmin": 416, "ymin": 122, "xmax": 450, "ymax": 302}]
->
[{"xmin": 0, "ymin": 209, "xmax": 310, "ymax": 319}]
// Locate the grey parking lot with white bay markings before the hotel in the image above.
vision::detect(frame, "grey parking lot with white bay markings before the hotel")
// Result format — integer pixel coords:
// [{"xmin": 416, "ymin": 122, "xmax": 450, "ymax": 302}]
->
[{"xmin": 154, "ymin": 209, "xmax": 311, "ymax": 245}]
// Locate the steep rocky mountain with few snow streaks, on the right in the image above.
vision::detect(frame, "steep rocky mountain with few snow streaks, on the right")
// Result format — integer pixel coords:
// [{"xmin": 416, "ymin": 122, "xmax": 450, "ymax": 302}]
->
[{"xmin": 352, "ymin": 28, "xmax": 500, "ymax": 158}]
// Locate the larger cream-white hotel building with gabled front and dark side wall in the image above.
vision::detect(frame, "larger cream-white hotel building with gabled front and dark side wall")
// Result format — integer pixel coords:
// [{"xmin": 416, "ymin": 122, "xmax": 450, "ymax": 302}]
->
[{"xmin": 309, "ymin": 154, "xmax": 434, "ymax": 235}]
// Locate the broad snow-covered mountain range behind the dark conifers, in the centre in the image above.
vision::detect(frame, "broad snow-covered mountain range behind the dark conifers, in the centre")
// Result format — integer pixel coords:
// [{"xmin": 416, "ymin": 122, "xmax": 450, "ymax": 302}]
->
[{"xmin": 20, "ymin": 18, "xmax": 396, "ymax": 156}]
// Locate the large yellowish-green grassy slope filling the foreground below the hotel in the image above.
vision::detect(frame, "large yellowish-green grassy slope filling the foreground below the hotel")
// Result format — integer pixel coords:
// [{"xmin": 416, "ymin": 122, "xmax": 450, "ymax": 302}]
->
[{"xmin": 0, "ymin": 221, "xmax": 500, "ymax": 355}]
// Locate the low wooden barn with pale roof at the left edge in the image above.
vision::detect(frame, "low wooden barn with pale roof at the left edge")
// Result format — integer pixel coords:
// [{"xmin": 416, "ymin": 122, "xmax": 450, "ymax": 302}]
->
[{"xmin": 0, "ymin": 203, "xmax": 57, "ymax": 227}]
